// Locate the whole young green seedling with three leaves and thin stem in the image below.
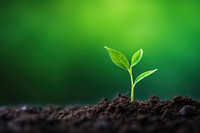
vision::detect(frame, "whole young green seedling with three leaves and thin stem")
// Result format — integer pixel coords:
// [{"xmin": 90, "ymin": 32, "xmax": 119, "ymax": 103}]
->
[{"xmin": 105, "ymin": 46, "xmax": 157, "ymax": 101}]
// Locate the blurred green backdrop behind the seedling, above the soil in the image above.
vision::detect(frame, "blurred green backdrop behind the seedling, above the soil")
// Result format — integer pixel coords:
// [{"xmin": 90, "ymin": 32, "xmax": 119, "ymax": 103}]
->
[{"xmin": 0, "ymin": 0, "xmax": 200, "ymax": 105}]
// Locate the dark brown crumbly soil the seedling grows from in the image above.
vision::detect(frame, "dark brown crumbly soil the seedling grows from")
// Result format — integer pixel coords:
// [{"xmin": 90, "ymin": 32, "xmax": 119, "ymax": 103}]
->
[{"xmin": 0, "ymin": 95, "xmax": 200, "ymax": 133}]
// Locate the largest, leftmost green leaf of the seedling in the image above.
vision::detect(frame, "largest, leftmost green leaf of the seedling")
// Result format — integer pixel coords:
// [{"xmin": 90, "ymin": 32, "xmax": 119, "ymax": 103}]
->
[{"xmin": 105, "ymin": 47, "xmax": 129, "ymax": 70}]
